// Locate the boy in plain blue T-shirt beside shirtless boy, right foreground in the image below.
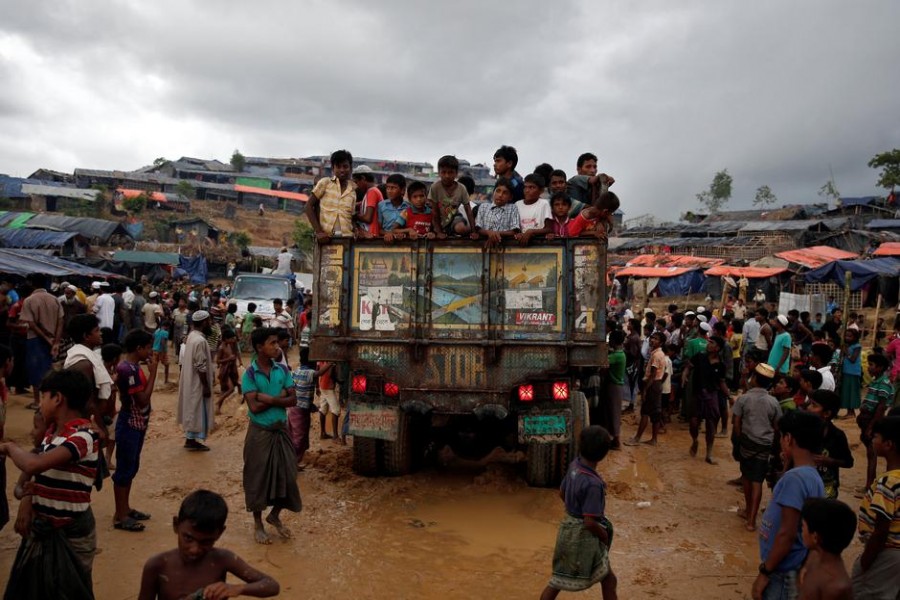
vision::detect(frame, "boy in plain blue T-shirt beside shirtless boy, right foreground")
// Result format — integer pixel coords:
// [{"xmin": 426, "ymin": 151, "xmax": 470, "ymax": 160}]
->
[{"xmin": 752, "ymin": 410, "xmax": 825, "ymax": 600}]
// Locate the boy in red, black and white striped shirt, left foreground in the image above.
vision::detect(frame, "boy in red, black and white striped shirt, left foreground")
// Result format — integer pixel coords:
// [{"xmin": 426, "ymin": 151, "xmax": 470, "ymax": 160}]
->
[{"xmin": 0, "ymin": 370, "xmax": 99, "ymax": 600}]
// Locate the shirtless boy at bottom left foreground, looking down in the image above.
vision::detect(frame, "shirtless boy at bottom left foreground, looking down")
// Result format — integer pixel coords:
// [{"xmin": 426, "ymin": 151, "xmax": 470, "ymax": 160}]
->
[{"xmin": 138, "ymin": 490, "xmax": 280, "ymax": 600}]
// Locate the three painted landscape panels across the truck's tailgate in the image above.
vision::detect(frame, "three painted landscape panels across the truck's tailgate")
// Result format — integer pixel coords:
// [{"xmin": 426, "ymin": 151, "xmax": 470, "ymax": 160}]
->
[{"xmin": 352, "ymin": 248, "xmax": 564, "ymax": 337}]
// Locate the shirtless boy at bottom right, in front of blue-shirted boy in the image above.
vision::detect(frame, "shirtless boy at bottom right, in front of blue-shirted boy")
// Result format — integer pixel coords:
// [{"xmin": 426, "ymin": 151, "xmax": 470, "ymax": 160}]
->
[{"xmin": 797, "ymin": 498, "xmax": 856, "ymax": 600}]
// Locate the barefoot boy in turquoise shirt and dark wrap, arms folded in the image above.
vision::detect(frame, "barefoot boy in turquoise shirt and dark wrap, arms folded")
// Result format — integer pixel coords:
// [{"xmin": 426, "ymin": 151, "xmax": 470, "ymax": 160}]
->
[{"xmin": 242, "ymin": 328, "xmax": 301, "ymax": 544}]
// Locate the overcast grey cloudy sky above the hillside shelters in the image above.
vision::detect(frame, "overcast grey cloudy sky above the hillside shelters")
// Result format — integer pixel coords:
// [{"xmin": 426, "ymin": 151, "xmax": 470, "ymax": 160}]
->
[{"xmin": 0, "ymin": 0, "xmax": 900, "ymax": 221}]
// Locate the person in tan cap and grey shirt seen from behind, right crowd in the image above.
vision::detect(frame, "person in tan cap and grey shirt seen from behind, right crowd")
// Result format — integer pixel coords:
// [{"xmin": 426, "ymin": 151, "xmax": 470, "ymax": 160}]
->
[{"xmin": 732, "ymin": 363, "xmax": 781, "ymax": 531}]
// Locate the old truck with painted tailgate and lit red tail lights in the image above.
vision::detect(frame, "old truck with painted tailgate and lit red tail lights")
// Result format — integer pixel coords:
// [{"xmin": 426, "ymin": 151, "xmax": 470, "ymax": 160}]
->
[{"xmin": 310, "ymin": 237, "xmax": 607, "ymax": 486}]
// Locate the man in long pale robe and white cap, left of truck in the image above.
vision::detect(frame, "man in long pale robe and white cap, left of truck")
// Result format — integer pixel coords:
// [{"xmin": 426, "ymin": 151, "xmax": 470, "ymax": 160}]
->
[{"xmin": 178, "ymin": 310, "xmax": 215, "ymax": 451}]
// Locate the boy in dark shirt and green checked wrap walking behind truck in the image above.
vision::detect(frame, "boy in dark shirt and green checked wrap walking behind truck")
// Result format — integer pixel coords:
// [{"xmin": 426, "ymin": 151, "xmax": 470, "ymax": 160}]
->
[{"xmin": 541, "ymin": 425, "xmax": 618, "ymax": 600}]
